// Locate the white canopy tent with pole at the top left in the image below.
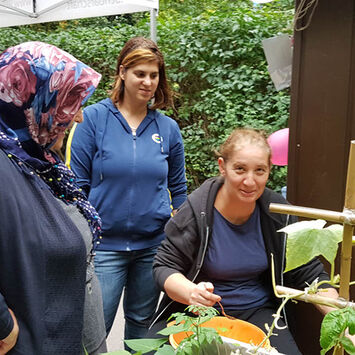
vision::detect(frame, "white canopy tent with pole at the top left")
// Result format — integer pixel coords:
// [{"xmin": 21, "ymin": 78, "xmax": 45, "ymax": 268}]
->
[{"xmin": 0, "ymin": 0, "xmax": 159, "ymax": 41}]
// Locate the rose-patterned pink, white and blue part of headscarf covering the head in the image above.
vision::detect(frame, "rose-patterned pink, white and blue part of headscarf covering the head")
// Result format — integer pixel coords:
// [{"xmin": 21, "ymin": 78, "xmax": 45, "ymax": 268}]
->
[{"xmin": 0, "ymin": 42, "xmax": 101, "ymax": 146}]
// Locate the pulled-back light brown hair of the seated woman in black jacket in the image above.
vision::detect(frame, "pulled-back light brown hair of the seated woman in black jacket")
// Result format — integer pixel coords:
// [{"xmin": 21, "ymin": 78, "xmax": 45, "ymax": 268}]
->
[{"xmin": 216, "ymin": 128, "xmax": 271, "ymax": 166}]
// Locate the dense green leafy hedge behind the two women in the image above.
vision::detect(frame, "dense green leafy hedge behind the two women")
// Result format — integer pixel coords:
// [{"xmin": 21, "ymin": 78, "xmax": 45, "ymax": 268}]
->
[{"xmin": 0, "ymin": 0, "xmax": 293, "ymax": 191}]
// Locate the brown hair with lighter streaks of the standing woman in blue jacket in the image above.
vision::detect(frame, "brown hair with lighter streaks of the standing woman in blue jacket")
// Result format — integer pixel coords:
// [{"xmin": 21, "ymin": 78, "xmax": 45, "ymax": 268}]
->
[{"xmin": 111, "ymin": 37, "xmax": 171, "ymax": 109}]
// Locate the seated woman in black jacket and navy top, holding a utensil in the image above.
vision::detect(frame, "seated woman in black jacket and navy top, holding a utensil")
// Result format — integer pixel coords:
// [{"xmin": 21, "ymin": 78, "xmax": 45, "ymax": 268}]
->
[{"xmin": 154, "ymin": 129, "xmax": 337, "ymax": 355}]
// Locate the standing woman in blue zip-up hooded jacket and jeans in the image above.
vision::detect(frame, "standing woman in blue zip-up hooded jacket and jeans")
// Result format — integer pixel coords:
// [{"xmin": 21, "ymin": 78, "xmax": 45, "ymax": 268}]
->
[{"xmin": 67, "ymin": 37, "xmax": 186, "ymax": 339}]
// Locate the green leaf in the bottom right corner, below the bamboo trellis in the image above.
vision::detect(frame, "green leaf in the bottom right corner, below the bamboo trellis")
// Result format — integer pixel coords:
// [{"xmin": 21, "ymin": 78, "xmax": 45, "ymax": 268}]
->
[{"xmin": 320, "ymin": 307, "xmax": 355, "ymax": 355}]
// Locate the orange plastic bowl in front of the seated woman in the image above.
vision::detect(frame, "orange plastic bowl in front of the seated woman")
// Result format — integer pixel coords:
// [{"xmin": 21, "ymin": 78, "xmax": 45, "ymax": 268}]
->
[{"xmin": 168, "ymin": 316, "xmax": 270, "ymax": 349}]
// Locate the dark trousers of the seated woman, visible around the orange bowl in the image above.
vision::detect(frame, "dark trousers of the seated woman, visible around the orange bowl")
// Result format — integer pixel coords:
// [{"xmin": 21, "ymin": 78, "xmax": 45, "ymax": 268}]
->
[{"xmin": 146, "ymin": 305, "xmax": 302, "ymax": 355}]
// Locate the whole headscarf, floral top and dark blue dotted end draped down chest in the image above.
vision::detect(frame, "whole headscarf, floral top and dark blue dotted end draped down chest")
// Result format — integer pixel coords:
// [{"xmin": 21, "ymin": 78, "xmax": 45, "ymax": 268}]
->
[{"xmin": 0, "ymin": 42, "xmax": 101, "ymax": 254}]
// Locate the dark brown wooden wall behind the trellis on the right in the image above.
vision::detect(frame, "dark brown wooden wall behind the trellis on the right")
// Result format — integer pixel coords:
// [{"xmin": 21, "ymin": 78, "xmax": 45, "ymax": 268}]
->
[{"xmin": 287, "ymin": 0, "xmax": 355, "ymax": 355}]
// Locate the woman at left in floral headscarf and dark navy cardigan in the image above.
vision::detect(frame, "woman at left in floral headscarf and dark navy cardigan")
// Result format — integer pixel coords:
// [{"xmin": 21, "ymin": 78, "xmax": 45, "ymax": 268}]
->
[{"xmin": 0, "ymin": 42, "xmax": 105, "ymax": 355}]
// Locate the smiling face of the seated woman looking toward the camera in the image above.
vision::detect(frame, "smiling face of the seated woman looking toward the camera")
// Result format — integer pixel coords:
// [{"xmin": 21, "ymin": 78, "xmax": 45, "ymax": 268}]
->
[{"xmin": 218, "ymin": 144, "xmax": 270, "ymax": 204}]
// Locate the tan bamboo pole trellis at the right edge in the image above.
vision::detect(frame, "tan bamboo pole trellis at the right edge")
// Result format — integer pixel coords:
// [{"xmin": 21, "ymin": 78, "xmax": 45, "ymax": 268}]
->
[{"xmin": 270, "ymin": 141, "xmax": 355, "ymax": 355}]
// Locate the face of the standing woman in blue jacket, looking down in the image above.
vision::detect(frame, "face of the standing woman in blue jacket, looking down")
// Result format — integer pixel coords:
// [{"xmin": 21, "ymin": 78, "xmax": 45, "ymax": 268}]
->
[{"xmin": 120, "ymin": 61, "xmax": 159, "ymax": 105}]
